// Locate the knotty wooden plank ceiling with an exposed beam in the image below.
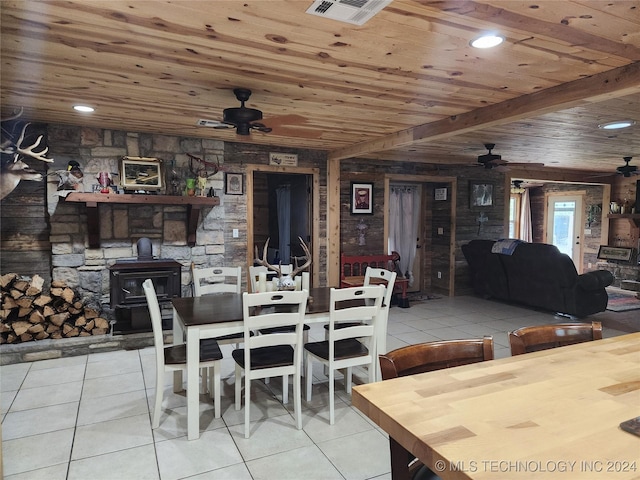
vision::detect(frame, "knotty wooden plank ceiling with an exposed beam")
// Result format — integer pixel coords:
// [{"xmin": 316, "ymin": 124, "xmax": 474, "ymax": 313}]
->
[{"xmin": 0, "ymin": 0, "xmax": 640, "ymax": 172}]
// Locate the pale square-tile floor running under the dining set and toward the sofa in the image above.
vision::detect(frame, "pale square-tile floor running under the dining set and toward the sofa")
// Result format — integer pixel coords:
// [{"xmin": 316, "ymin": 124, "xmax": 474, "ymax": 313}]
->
[{"xmin": 0, "ymin": 296, "xmax": 625, "ymax": 480}]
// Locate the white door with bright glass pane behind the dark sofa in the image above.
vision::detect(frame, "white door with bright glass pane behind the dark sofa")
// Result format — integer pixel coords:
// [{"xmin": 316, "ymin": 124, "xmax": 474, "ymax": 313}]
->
[{"xmin": 545, "ymin": 194, "xmax": 583, "ymax": 272}]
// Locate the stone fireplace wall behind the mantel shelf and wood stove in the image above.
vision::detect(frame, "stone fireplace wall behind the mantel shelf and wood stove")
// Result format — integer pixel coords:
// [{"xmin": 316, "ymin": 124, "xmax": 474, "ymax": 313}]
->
[{"xmin": 48, "ymin": 125, "xmax": 326, "ymax": 319}]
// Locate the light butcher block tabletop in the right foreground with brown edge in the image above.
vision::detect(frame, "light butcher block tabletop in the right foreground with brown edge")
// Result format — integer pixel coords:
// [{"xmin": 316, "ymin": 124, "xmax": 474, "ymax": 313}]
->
[{"xmin": 352, "ymin": 333, "xmax": 640, "ymax": 480}]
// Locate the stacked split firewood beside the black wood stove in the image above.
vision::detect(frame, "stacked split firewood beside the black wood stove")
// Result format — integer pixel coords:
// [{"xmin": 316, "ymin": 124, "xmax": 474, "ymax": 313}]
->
[{"xmin": 0, "ymin": 273, "xmax": 109, "ymax": 343}]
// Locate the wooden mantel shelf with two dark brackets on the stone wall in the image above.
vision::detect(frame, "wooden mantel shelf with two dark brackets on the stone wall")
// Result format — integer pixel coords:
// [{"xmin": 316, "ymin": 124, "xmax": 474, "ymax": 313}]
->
[{"xmin": 64, "ymin": 192, "xmax": 220, "ymax": 248}]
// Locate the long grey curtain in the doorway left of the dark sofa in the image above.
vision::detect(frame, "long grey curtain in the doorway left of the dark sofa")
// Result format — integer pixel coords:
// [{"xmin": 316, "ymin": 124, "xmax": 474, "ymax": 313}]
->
[{"xmin": 388, "ymin": 185, "xmax": 420, "ymax": 286}]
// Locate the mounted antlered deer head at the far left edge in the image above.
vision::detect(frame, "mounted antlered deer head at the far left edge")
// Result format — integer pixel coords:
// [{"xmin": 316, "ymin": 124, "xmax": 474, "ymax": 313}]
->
[{"xmin": 0, "ymin": 109, "xmax": 53, "ymax": 199}]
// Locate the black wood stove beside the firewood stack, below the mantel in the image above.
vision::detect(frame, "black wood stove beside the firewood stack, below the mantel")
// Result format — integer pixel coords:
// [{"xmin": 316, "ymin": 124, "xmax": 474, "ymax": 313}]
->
[{"xmin": 109, "ymin": 257, "xmax": 182, "ymax": 333}]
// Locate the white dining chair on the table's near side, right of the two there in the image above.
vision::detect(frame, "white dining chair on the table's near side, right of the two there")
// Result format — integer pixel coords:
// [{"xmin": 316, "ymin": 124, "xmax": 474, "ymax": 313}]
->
[{"xmin": 304, "ymin": 285, "xmax": 385, "ymax": 425}]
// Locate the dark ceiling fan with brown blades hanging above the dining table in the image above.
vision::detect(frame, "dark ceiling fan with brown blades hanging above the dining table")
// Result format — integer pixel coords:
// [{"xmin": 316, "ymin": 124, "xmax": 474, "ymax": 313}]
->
[{"xmin": 196, "ymin": 88, "xmax": 322, "ymax": 138}]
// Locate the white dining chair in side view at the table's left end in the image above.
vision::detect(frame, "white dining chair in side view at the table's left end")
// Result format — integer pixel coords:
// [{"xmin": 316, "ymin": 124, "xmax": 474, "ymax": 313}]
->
[{"xmin": 142, "ymin": 278, "xmax": 222, "ymax": 428}]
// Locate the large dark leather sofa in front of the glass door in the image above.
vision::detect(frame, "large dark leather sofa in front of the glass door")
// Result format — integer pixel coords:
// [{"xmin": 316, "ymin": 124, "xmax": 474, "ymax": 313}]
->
[{"xmin": 462, "ymin": 240, "xmax": 613, "ymax": 317}]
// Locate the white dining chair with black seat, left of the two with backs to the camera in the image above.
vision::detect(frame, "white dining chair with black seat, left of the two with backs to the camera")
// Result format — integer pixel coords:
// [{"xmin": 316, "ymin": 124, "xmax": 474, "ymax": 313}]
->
[{"xmin": 232, "ymin": 290, "xmax": 309, "ymax": 438}]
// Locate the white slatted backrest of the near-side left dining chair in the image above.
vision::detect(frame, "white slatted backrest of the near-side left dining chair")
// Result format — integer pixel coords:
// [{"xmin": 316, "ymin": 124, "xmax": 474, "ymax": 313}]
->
[{"xmin": 242, "ymin": 290, "xmax": 309, "ymax": 368}]
